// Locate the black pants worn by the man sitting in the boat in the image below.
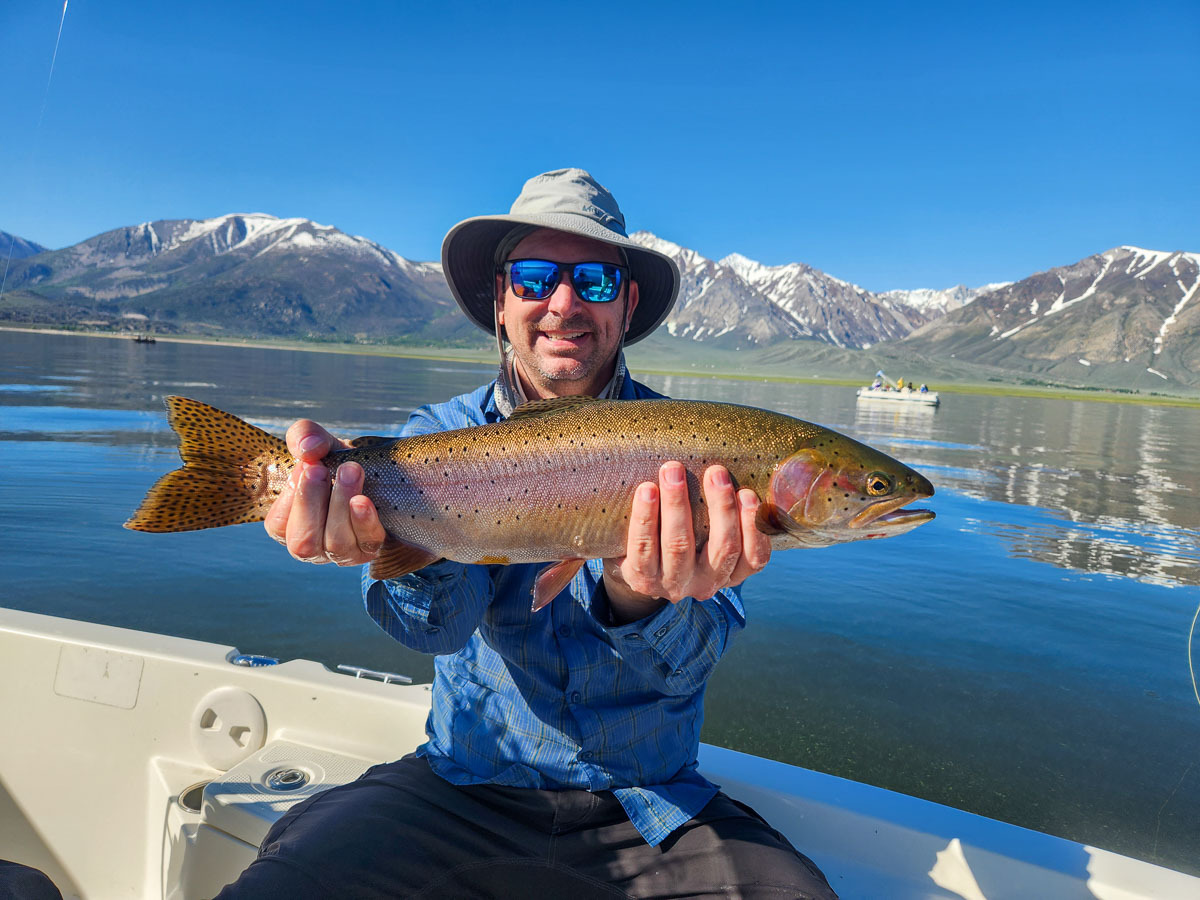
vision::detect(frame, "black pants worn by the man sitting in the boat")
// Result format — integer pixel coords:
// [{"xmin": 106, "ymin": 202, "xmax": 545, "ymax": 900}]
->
[{"xmin": 217, "ymin": 756, "xmax": 836, "ymax": 900}]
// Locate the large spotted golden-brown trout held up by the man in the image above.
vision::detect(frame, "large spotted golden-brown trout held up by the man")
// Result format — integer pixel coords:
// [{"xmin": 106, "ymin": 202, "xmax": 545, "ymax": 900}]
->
[{"xmin": 126, "ymin": 397, "xmax": 934, "ymax": 610}]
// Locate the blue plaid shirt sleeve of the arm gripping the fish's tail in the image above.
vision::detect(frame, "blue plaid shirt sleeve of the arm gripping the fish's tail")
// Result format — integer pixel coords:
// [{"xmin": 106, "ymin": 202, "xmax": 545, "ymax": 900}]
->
[{"xmin": 362, "ymin": 406, "xmax": 496, "ymax": 653}]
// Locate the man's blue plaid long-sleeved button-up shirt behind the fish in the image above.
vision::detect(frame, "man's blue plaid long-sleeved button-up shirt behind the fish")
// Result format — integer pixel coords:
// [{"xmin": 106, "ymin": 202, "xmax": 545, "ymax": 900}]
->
[{"xmin": 362, "ymin": 378, "xmax": 745, "ymax": 845}]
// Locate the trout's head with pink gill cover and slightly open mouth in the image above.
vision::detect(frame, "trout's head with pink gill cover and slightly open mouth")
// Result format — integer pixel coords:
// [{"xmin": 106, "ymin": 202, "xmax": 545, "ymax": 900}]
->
[{"xmin": 760, "ymin": 430, "xmax": 934, "ymax": 546}]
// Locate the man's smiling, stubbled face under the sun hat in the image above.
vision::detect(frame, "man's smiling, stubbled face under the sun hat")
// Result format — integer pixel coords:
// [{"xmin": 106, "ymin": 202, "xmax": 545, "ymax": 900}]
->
[{"xmin": 496, "ymin": 229, "xmax": 637, "ymax": 400}]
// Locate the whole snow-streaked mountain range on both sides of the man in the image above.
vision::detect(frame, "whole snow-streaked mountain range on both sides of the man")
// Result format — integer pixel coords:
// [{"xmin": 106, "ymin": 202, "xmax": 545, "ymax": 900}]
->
[{"xmin": 0, "ymin": 214, "xmax": 1200, "ymax": 390}]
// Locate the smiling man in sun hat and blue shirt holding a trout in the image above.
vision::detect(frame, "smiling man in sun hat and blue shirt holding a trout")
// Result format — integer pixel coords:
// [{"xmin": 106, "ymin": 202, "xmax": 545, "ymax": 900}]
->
[{"xmin": 220, "ymin": 169, "xmax": 835, "ymax": 900}]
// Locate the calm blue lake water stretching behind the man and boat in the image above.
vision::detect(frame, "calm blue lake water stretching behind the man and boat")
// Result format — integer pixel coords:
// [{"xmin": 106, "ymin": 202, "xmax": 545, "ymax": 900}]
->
[{"xmin": 7, "ymin": 332, "xmax": 1200, "ymax": 874}]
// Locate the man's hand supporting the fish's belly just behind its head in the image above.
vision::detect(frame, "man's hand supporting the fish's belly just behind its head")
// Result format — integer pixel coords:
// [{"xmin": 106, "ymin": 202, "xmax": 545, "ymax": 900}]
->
[{"xmin": 604, "ymin": 462, "xmax": 770, "ymax": 622}]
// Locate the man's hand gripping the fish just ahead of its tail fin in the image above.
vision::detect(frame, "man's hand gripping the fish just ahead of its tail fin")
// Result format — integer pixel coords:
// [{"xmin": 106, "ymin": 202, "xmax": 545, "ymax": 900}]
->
[{"xmin": 264, "ymin": 419, "xmax": 386, "ymax": 565}]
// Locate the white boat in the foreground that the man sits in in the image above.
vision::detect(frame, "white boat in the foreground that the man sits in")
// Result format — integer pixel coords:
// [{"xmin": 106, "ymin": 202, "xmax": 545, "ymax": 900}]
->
[{"xmin": 0, "ymin": 608, "xmax": 1200, "ymax": 900}]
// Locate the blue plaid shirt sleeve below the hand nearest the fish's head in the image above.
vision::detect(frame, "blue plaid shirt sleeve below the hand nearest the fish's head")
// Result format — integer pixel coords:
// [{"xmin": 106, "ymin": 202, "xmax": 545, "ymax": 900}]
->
[{"xmin": 588, "ymin": 560, "xmax": 746, "ymax": 696}]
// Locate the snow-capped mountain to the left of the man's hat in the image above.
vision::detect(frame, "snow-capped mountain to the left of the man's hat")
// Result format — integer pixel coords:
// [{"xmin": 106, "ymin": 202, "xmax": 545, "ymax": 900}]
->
[{"xmin": 0, "ymin": 214, "xmax": 473, "ymax": 342}]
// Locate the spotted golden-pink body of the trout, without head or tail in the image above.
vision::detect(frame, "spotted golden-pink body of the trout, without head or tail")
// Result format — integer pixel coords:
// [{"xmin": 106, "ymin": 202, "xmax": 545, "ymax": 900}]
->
[{"xmin": 345, "ymin": 400, "xmax": 854, "ymax": 563}]
